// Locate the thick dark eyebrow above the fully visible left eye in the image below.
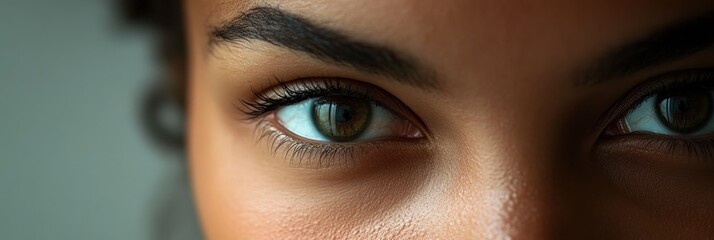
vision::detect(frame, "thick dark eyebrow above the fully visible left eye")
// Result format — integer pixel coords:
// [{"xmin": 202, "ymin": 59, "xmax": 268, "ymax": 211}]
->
[{"xmin": 210, "ymin": 7, "xmax": 435, "ymax": 87}]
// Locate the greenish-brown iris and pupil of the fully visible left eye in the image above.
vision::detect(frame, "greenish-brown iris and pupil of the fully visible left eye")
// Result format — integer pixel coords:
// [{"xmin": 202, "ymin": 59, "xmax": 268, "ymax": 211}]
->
[{"xmin": 312, "ymin": 96, "xmax": 372, "ymax": 141}]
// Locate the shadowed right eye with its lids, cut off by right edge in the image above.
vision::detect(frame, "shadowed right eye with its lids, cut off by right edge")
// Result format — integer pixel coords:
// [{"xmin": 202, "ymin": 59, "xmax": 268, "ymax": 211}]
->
[{"xmin": 602, "ymin": 69, "xmax": 714, "ymax": 165}]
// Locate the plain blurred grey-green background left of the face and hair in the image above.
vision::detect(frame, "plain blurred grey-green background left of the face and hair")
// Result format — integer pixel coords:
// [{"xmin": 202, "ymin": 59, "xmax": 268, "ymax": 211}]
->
[{"xmin": 0, "ymin": 0, "xmax": 200, "ymax": 240}]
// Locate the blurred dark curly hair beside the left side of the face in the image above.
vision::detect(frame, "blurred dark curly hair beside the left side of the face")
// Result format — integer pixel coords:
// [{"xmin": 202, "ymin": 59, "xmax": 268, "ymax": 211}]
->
[{"xmin": 117, "ymin": 0, "xmax": 201, "ymax": 239}]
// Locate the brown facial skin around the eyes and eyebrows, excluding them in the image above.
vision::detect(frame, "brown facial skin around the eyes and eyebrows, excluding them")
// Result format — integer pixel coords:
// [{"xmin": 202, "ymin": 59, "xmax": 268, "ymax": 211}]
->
[{"xmin": 185, "ymin": 0, "xmax": 714, "ymax": 239}]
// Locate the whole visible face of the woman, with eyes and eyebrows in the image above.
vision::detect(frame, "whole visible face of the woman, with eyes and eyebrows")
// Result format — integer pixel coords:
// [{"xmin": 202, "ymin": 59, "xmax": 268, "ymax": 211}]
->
[{"xmin": 184, "ymin": 0, "xmax": 714, "ymax": 239}]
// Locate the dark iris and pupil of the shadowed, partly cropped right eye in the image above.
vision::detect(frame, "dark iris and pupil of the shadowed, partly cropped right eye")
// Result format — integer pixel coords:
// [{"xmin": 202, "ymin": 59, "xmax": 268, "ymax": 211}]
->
[{"xmin": 657, "ymin": 88, "xmax": 714, "ymax": 134}]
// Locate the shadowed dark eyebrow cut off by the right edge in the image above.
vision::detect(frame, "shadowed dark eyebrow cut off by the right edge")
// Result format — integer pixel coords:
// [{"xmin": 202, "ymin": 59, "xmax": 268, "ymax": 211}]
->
[{"xmin": 578, "ymin": 11, "xmax": 714, "ymax": 85}]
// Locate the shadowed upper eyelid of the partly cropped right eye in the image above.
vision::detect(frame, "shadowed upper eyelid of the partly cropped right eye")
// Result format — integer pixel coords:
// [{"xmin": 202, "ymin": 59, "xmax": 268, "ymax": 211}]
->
[{"xmin": 597, "ymin": 68, "xmax": 714, "ymax": 135}]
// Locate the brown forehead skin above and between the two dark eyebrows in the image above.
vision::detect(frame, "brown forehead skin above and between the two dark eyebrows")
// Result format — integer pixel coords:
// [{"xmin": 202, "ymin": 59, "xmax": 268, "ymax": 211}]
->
[{"xmin": 188, "ymin": 0, "xmax": 713, "ymax": 77}]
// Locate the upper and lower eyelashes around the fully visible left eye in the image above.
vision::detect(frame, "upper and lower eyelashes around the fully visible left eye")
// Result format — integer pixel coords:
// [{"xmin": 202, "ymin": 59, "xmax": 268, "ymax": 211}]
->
[{"xmin": 236, "ymin": 78, "xmax": 404, "ymax": 169}]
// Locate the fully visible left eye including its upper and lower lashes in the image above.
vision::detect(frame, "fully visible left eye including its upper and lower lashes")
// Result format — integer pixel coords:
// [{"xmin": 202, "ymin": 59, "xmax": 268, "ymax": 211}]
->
[{"xmin": 238, "ymin": 78, "xmax": 425, "ymax": 168}]
